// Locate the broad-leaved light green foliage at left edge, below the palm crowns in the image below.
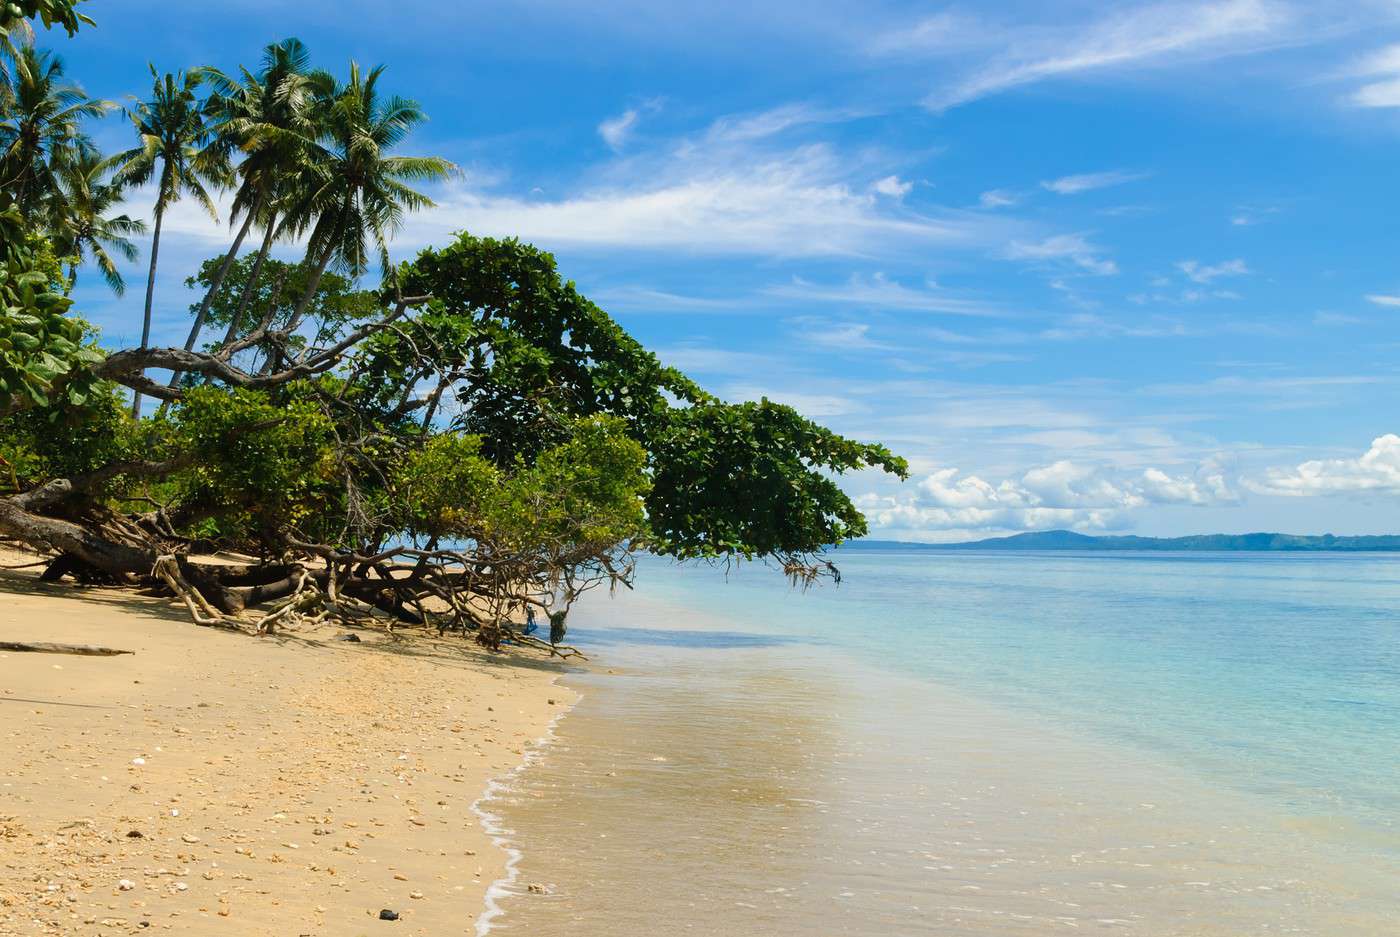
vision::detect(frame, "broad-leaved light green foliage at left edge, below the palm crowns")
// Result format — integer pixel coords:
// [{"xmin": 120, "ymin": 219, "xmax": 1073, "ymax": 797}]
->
[{"xmin": 0, "ymin": 206, "xmax": 102, "ymax": 413}]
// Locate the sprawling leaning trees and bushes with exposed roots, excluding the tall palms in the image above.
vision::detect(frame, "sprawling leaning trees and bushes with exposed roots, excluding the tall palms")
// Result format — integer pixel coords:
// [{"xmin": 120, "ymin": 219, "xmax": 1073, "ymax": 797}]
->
[{"xmin": 0, "ymin": 219, "xmax": 906, "ymax": 647}]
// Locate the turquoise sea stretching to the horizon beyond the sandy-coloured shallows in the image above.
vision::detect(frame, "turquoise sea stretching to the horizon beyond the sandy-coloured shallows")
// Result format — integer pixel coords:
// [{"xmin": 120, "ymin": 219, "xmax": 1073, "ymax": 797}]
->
[{"xmin": 616, "ymin": 552, "xmax": 1400, "ymax": 832}]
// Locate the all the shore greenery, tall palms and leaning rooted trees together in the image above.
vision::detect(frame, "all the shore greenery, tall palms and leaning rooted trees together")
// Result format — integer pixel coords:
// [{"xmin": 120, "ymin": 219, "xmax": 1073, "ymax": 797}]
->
[{"xmin": 0, "ymin": 0, "xmax": 906, "ymax": 653}]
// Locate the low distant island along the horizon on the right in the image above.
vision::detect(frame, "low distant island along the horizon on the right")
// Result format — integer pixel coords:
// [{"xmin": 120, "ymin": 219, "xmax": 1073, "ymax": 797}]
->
[{"xmin": 841, "ymin": 531, "xmax": 1400, "ymax": 553}]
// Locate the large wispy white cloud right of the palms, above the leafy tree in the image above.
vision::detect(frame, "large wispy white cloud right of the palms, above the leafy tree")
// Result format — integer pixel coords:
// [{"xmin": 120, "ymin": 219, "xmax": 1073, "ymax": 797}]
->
[{"xmin": 399, "ymin": 108, "xmax": 1018, "ymax": 256}]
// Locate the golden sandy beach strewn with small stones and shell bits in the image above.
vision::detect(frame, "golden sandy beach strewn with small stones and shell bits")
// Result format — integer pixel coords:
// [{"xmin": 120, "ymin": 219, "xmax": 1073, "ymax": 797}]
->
[{"xmin": 0, "ymin": 553, "xmax": 573, "ymax": 937}]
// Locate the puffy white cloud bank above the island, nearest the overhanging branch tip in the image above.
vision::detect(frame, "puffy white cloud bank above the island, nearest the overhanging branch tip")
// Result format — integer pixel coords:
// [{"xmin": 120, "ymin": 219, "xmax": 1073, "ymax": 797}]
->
[{"xmin": 858, "ymin": 459, "xmax": 1239, "ymax": 534}]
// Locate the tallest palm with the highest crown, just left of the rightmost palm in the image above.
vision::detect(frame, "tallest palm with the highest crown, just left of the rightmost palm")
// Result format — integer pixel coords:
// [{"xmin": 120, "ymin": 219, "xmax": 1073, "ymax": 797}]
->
[{"xmin": 182, "ymin": 38, "xmax": 315, "ymax": 358}]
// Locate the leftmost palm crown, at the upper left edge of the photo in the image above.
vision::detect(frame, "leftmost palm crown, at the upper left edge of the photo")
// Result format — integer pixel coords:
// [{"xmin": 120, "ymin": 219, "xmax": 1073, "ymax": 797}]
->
[{"xmin": 0, "ymin": 45, "xmax": 112, "ymax": 220}]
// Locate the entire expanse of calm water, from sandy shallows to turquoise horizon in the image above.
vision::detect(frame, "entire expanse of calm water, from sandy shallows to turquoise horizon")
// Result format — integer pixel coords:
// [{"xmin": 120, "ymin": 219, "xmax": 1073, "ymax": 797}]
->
[{"xmin": 478, "ymin": 553, "xmax": 1400, "ymax": 937}]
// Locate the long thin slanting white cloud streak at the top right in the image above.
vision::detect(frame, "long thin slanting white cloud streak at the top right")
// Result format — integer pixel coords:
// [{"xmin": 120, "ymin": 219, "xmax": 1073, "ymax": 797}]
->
[{"xmin": 927, "ymin": 0, "xmax": 1292, "ymax": 109}]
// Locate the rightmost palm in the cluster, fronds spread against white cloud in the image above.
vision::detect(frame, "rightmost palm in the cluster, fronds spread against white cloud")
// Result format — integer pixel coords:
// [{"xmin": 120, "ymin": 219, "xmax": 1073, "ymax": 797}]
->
[{"xmin": 284, "ymin": 62, "xmax": 455, "ymax": 329}]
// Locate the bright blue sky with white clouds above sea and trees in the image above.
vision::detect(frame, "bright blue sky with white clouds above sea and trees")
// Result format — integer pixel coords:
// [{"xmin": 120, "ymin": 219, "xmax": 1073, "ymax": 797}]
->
[{"xmin": 35, "ymin": 0, "xmax": 1400, "ymax": 541}]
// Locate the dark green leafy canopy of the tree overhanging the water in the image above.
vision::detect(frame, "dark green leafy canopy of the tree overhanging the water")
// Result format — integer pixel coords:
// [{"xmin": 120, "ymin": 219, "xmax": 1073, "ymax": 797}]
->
[{"xmin": 397, "ymin": 235, "xmax": 907, "ymax": 557}]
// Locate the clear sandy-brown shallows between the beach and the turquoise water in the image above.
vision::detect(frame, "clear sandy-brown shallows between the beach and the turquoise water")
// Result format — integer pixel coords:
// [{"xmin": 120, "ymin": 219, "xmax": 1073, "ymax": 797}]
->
[{"xmin": 478, "ymin": 579, "xmax": 1396, "ymax": 937}]
